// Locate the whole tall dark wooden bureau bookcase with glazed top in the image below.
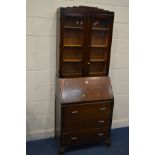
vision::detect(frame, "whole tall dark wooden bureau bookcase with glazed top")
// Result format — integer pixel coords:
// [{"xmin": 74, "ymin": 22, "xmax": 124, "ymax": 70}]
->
[{"xmin": 55, "ymin": 6, "xmax": 114, "ymax": 154}]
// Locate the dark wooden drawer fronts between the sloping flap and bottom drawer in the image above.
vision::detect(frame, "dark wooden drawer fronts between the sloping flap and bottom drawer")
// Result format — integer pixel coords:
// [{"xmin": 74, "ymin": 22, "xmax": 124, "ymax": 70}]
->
[{"xmin": 62, "ymin": 103, "xmax": 113, "ymax": 131}]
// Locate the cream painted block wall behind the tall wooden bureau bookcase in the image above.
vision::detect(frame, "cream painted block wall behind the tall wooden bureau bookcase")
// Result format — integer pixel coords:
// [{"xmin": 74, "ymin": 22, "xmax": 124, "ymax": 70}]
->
[{"xmin": 26, "ymin": 0, "xmax": 129, "ymax": 140}]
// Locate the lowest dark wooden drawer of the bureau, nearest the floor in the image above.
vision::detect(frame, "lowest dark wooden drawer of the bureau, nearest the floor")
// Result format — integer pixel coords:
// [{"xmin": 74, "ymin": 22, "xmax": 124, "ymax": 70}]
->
[{"xmin": 63, "ymin": 128, "xmax": 110, "ymax": 146}]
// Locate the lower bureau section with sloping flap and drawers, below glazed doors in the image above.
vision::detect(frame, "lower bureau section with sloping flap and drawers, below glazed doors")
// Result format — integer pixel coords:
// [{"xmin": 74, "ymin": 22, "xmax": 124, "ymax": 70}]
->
[{"xmin": 56, "ymin": 77, "xmax": 114, "ymax": 153}]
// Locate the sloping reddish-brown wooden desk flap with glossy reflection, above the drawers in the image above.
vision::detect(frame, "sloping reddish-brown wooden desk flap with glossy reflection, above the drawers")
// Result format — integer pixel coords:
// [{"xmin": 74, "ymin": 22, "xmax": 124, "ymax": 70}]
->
[{"xmin": 59, "ymin": 77, "xmax": 113, "ymax": 103}]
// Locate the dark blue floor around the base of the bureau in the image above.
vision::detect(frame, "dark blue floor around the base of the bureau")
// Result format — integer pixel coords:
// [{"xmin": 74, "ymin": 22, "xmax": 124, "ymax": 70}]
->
[{"xmin": 26, "ymin": 127, "xmax": 129, "ymax": 155}]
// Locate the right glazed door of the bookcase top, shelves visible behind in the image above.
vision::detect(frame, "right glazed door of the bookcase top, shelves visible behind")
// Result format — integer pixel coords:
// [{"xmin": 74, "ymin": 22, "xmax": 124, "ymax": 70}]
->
[{"xmin": 88, "ymin": 15, "xmax": 112, "ymax": 76}]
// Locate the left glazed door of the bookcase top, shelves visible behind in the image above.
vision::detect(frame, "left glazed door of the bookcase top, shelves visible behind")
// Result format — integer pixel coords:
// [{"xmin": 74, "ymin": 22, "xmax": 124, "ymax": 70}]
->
[{"xmin": 61, "ymin": 13, "xmax": 86, "ymax": 77}]
